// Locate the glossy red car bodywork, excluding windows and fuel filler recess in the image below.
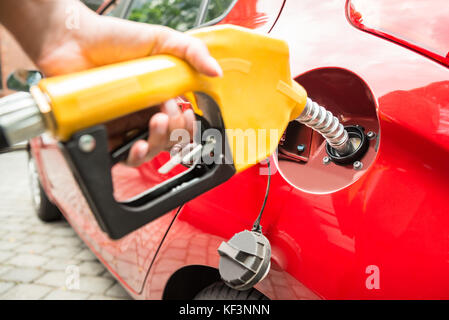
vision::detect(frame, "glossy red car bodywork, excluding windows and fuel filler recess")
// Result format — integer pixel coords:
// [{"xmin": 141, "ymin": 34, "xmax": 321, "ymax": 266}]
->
[{"xmin": 32, "ymin": 0, "xmax": 449, "ymax": 299}]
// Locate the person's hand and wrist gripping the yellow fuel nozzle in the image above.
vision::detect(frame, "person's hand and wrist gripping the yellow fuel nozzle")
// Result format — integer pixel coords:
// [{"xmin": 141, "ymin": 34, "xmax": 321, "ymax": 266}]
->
[{"xmin": 0, "ymin": 0, "xmax": 222, "ymax": 166}]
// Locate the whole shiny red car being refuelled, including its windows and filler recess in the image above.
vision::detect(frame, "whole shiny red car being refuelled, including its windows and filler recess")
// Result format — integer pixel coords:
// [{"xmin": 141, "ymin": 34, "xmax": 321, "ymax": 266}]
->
[{"xmin": 30, "ymin": 0, "xmax": 449, "ymax": 299}]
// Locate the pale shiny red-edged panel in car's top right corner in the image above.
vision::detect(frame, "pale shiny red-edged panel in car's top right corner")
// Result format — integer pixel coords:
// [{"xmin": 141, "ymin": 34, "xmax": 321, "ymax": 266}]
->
[{"xmin": 347, "ymin": 0, "xmax": 449, "ymax": 65}]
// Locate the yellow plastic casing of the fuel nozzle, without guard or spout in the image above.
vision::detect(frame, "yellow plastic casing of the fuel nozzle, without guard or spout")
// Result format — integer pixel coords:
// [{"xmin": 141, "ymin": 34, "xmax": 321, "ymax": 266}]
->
[{"xmin": 32, "ymin": 26, "xmax": 307, "ymax": 171}]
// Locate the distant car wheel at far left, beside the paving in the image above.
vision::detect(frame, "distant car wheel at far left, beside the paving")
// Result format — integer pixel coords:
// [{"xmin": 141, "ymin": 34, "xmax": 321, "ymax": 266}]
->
[{"xmin": 28, "ymin": 154, "xmax": 62, "ymax": 222}]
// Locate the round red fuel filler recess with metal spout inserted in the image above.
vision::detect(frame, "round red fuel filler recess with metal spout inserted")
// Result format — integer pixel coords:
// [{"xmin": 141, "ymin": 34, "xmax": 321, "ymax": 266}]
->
[{"xmin": 274, "ymin": 67, "xmax": 382, "ymax": 194}]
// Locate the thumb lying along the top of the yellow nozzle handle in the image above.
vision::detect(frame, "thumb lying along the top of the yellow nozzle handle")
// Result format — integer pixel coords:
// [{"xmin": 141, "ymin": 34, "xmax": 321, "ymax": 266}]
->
[{"xmin": 151, "ymin": 29, "xmax": 223, "ymax": 77}]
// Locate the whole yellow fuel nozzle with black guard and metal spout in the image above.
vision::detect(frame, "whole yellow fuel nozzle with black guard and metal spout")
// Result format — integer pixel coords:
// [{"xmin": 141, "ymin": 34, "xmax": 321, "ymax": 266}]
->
[{"xmin": 0, "ymin": 26, "xmax": 356, "ymax": 239}]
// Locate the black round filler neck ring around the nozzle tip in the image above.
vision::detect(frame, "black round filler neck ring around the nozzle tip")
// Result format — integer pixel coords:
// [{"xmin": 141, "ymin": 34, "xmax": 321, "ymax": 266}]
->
[{"xmin": 326, "ymin": 125, "xmax": 368, "ymax": 165}]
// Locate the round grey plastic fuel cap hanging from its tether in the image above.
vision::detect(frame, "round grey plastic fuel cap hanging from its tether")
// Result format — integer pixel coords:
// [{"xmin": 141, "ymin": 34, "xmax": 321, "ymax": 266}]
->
[{"xmin": 218, "ymin": 230, "xmax": 271, "ymax": 290}]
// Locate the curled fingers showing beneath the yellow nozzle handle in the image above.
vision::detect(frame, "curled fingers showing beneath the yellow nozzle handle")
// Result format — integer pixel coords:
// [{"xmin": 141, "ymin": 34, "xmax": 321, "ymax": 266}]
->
[{"xmin": 127, "ymin": 100, "xmax": 195, "ymax": 167}]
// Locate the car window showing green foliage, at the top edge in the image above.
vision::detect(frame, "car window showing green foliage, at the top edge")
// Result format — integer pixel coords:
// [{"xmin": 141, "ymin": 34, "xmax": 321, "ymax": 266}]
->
[{"xmin": 128, "ymin": 0, "xmax": 236, "ymax": 31}]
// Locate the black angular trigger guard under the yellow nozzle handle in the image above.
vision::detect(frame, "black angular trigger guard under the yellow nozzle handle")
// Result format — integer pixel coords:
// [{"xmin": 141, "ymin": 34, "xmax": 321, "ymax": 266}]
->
[{"xmin": 60, "ymin": 125, "xmax": 236, "ymax": 239}]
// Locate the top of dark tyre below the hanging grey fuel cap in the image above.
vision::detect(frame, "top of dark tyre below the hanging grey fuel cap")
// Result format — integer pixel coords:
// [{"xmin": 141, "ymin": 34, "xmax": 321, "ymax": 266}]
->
[{"xmin": 194, "ymin": 282, "xmax": 268, "ymax": 300}]
